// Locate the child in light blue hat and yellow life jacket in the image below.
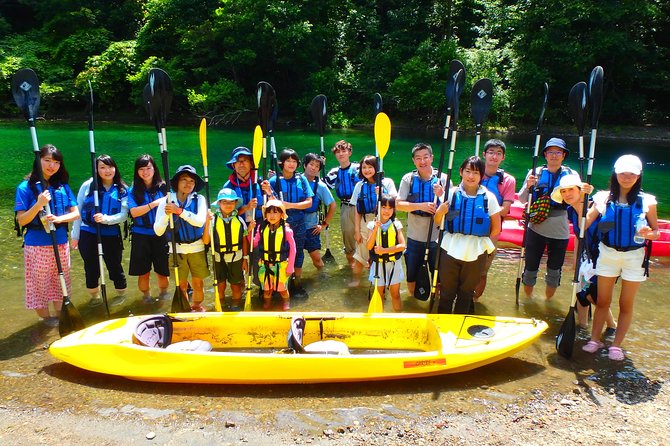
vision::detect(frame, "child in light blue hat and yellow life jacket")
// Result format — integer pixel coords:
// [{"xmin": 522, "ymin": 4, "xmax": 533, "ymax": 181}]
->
[{"xmin": 211, "ymin": 188, "xmax": 249, "ymax": 311}]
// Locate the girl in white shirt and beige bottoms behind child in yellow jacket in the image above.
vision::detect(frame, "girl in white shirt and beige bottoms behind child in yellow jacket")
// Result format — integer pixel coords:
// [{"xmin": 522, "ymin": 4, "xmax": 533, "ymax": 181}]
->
[{"xmin": 349, "ymin": 155, "xmax": 398, "ymax": 287}]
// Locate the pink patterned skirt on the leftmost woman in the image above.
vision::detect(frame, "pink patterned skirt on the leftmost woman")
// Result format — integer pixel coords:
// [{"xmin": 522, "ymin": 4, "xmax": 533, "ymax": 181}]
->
[{"xmin": 23, "ymin": 243, "xmax": 71, "ymax": 310}]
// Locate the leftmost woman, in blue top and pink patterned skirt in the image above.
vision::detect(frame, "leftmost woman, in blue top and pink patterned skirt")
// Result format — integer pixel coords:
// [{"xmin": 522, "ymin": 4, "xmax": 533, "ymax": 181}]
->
[{"xmin": 14, "ymin": 144, "xmax": 79, "ymax": 327}]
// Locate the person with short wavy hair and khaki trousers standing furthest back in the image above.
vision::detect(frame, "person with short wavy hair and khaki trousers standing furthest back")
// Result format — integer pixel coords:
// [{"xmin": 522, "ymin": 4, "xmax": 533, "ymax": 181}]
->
[{"xmin": 323, "ymin": 140, "xmax": 359, "ymax": 267}]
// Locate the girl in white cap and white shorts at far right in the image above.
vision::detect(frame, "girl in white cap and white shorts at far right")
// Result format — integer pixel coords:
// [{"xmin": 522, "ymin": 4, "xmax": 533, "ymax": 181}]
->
[{"xmin": 582, "ymin": 155, "xmax": 660, "ymax": 361}]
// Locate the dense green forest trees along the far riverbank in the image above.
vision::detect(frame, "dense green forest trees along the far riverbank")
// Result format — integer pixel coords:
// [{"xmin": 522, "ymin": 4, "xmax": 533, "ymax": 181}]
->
[{"xmin": 0, "ymin": 0, "xmax": 670, "ymax": 128}]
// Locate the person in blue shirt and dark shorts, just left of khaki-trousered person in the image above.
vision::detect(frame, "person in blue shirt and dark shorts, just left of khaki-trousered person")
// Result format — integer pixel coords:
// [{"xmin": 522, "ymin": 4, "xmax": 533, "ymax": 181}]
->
[{"xmin": 302, "ymin": 153, "xmax": 337, "ymax": 269}]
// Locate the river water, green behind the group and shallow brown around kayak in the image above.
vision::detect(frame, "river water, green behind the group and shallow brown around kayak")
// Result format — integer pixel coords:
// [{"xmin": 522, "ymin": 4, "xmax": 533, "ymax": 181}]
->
[{"xmin": 0, "ymin": 125, "xmax": 670, "ymax": 429}]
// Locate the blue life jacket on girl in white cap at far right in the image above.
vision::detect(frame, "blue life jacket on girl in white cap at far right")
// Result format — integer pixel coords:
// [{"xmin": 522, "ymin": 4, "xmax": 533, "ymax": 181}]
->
[{"xmin": 598, "ymin": 194, "xmax": 645, "ymax": 251}]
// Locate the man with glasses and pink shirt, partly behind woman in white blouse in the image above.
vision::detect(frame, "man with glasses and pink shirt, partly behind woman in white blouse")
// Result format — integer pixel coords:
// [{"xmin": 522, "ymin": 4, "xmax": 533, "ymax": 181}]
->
[{"xmin": 474, "ymin": 139, "xmax": 516, "ymax": 302}]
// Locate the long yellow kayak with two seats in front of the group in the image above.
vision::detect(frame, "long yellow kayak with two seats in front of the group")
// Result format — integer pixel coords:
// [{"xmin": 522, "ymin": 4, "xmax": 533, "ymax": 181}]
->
[{"xmin": 49, "ymin": 312, "xmax": 547, "ymax": 384}]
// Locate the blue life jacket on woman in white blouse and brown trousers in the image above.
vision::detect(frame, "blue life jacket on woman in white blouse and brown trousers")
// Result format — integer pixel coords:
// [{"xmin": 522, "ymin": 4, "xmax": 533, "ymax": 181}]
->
[{"xmin": 447, "ymin": 188, "xmax": 491, "ymax": 237}]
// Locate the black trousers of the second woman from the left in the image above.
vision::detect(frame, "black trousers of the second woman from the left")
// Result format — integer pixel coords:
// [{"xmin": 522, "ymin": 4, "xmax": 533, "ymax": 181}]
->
[{"xmin": 79, "ymin": 231, "xmax": 127, "ymax": 290}]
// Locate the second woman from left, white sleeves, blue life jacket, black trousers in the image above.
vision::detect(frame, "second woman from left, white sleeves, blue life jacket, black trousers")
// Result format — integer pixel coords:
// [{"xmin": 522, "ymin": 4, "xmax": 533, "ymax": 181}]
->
[{"xmin": 72, "ymin": 155, "xmax": 128, "ymax": 305}]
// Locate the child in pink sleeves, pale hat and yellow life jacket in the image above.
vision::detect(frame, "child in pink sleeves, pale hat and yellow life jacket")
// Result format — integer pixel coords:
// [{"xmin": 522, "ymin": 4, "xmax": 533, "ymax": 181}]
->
[{"xmin": 249, "ymin": 199, "xmax": 296, "ymax": 311}]
